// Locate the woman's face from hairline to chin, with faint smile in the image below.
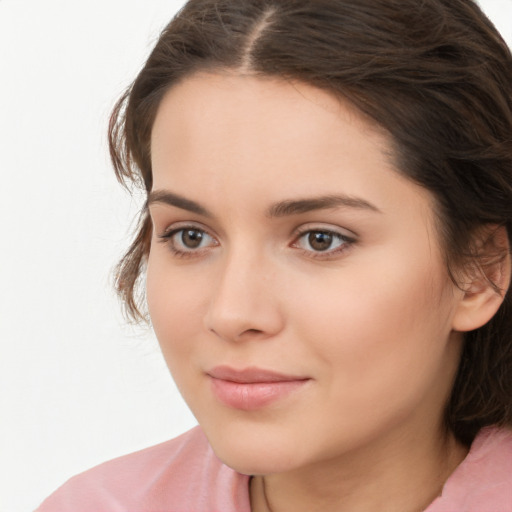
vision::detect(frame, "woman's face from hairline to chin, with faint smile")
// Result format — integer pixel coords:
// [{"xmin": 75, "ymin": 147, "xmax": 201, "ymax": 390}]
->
[{"xmin": 147, "ymin": 74, "xmax": 461, "ymax": 474}]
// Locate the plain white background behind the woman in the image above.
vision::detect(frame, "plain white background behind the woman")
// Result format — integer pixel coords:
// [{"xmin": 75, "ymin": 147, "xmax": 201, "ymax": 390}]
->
[{"xmin": 0, "ymin": 0, "xmax": 512, "ymax": 512}]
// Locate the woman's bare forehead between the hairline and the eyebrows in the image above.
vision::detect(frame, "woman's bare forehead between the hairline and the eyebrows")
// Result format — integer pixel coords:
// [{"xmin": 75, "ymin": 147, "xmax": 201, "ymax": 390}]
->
[{"xmin": 151, "ymin": 74, "xmax": 429, "ymax": 223}]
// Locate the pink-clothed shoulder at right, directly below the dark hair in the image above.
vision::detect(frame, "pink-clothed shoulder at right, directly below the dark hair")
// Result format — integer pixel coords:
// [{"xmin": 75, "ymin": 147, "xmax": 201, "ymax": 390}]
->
[{"xmin": 427, "ymin": 427, "xmax": 512, "ymax": 512}]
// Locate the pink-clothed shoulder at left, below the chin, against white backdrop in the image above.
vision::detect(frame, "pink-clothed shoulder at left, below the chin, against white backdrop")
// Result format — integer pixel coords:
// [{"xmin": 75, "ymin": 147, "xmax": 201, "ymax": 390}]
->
[{"xmin": 37, "ymin": 427, "xmax": 250, "ymax": 512}]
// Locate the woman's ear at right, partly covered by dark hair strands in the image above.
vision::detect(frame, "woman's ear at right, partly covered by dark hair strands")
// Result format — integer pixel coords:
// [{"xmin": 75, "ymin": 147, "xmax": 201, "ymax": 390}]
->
[{"xmin": 452, "ymin": 225, "xmax": 511, "ymax": 332}]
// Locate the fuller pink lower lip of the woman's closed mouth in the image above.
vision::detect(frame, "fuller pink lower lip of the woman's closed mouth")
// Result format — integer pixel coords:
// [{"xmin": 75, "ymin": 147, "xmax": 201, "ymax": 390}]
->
[{"xmin": 211, "ymin": 378, "xmax": 308, "ymax": 411}]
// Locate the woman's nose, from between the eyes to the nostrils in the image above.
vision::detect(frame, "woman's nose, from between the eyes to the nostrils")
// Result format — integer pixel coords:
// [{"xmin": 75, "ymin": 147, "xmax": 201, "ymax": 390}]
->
[{"xmin": 205, "ymin": 246, "xmax": 284, "ymax": 342}]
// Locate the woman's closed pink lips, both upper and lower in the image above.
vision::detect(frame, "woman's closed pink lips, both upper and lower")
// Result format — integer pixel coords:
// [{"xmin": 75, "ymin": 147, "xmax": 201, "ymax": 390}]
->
[{"xmin": 207, "ymin": 366, "xmax": 311, "ymax": 411}]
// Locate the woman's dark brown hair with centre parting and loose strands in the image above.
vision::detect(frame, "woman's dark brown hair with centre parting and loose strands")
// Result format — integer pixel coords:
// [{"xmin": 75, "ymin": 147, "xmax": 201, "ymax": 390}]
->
[{"xmin": 109, "ymin": 0, "xmax": 512, "ymax": 444}]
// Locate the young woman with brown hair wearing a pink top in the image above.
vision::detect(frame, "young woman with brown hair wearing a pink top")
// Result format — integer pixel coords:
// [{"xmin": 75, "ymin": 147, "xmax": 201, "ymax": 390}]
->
[{"xmin": 39, "ymin": 0, "xmax": 512, "ymax": 512}]
